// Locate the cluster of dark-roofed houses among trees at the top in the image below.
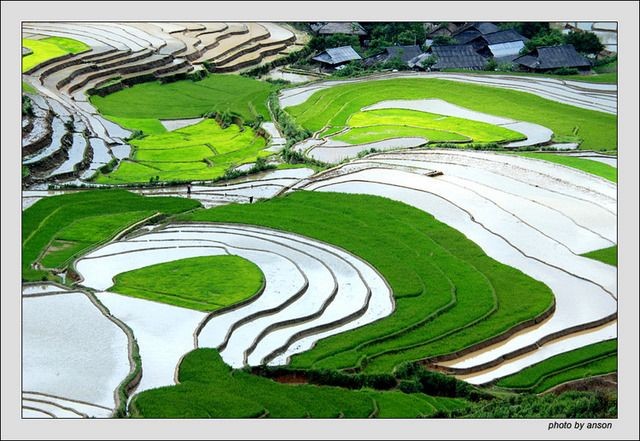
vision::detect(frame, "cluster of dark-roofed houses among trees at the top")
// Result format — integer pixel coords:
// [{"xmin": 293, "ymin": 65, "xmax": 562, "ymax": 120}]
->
[{"xmin": 312, "ymin": 22, "xmax": 591, "ymax": 72}]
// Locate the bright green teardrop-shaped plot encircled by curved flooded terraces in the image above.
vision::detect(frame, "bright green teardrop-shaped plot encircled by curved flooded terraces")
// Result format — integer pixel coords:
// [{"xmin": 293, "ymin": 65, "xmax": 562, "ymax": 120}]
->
[{"xmin": 109, "ymin": 256, "xmax": 264, "ymax": 312}]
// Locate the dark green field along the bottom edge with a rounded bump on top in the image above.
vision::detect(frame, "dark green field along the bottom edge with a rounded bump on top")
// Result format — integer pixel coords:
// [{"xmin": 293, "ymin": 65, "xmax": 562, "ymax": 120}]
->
[{"xmin": 130, "ymin": 349, "xmax": 467, "ymax": 418}]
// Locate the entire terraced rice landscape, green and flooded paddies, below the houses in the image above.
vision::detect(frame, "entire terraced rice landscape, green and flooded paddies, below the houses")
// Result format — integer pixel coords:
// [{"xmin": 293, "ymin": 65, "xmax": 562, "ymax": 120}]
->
[{"xmin": 22, "ymin": 22, "xmax": 618, "ymax": 418}]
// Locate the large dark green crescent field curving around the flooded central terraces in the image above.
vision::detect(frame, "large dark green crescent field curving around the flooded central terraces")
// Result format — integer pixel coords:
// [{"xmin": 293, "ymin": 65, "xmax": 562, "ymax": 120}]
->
[{"xmin": 180, "ymin": 191, "xmax": 553, "ymax": 372}]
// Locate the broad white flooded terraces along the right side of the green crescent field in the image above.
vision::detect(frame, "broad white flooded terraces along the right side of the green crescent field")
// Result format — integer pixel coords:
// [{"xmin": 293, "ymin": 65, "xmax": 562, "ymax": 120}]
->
[{"xmin": 294, "ymin": 151, "xmax": 617, "ymax": 382}]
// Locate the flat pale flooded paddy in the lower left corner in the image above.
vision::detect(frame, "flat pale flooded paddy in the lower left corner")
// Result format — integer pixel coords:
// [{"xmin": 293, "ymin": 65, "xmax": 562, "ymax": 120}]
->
[{"xmin": 22, "ymin": 285, "xmax": 130, "ymax": 418}]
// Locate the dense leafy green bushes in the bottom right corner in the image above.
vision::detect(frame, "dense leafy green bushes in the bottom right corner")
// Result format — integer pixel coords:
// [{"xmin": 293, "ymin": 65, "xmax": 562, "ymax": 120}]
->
[{"xmin": 448, "ymin": 392, "xmax": 618, "ymax": 418}]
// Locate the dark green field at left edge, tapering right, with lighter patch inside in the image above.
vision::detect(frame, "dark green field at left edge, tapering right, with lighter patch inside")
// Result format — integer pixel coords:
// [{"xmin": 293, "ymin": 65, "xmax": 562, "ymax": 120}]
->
[{"xmin": 22, "ymin": 190, "xmax": 200, "ymax": 281}]
